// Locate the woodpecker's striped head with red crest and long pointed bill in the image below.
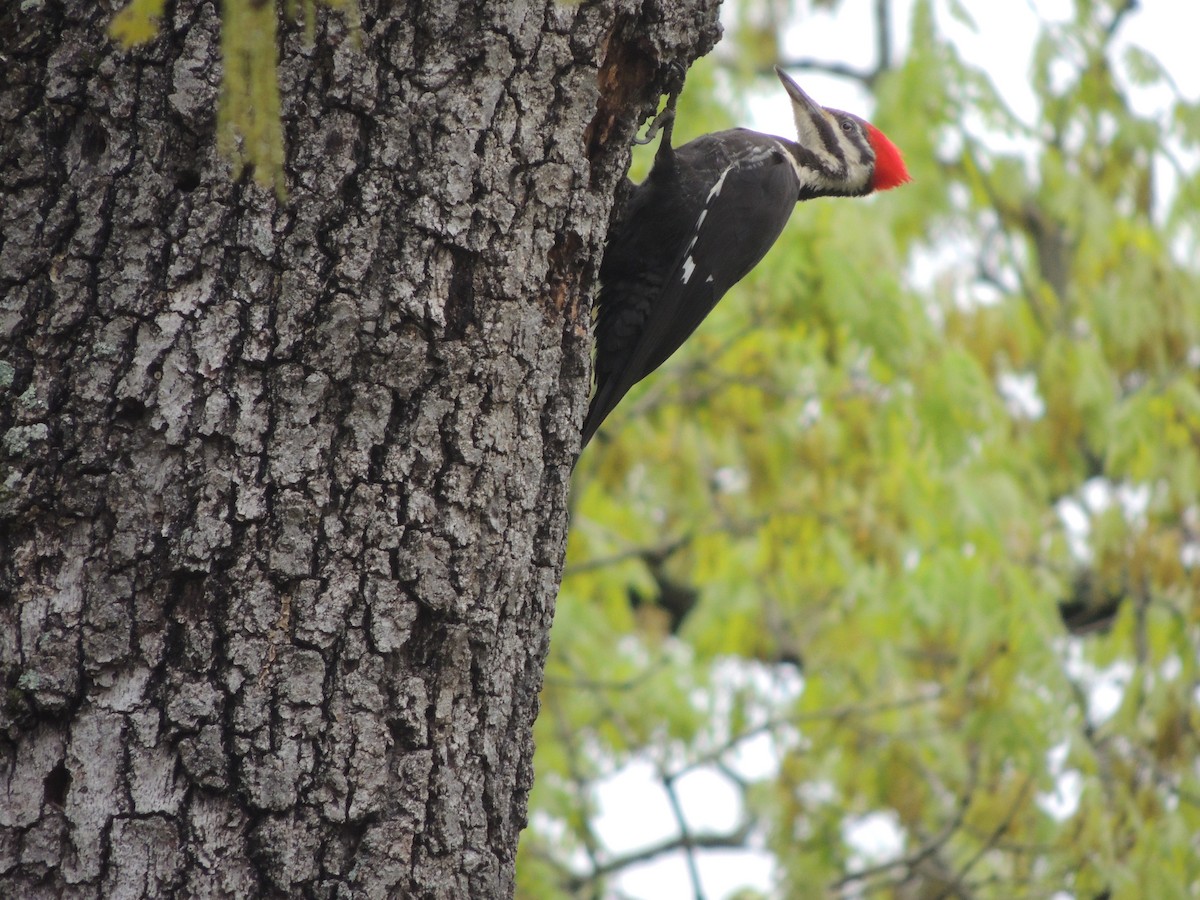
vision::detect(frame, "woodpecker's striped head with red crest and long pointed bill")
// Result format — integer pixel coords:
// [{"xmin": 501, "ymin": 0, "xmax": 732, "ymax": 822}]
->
[{"xmin": 775, "ymin": 66, "xmax": 910, "ymax": 197}]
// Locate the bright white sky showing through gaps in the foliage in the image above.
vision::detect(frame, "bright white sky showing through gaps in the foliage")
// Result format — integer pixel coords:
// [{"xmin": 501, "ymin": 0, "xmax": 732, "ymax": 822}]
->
[{"xmin": 595, "ymin": 0, "xmax": 1200, "ymax": 900}]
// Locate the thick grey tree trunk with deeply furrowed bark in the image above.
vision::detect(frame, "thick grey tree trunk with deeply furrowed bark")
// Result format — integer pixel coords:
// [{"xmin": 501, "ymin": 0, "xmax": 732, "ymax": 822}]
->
[{"xmin": 0, "ymin": 0, "xmax": 718, "ymax": 898}]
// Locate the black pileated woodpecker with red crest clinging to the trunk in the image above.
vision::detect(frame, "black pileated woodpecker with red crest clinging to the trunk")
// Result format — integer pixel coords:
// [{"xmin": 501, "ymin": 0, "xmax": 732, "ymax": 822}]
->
[{"xmin": 583, "ymin": 66, "xmax": 908, "ymax": 446}]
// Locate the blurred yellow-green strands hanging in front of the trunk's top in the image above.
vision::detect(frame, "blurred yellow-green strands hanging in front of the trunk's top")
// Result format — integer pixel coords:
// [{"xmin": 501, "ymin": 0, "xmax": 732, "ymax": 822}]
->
[{"xmin": 108, "ymin": 0, "xmax": 359, "ymax": 198}]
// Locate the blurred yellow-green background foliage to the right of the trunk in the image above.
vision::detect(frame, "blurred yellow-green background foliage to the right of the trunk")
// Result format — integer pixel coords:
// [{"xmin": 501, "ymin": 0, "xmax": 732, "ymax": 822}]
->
[{"xmin": 530, "ymin": 0, "xmax": 1200, "ymax": 899}]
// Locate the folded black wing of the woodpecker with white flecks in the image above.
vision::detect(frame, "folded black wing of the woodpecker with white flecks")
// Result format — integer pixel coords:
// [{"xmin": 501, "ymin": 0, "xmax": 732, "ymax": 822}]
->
[{"xmin": 583, "ymin": 142, "xmax": 799, "ymax": 444}]
